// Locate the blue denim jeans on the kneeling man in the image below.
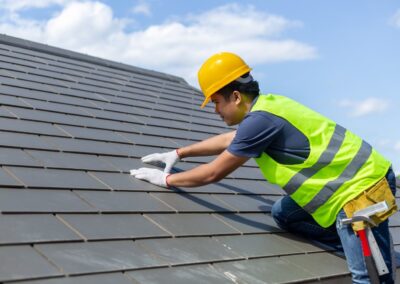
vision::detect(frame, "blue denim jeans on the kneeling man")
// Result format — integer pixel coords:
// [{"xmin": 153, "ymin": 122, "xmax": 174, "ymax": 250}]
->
[{"xmin": 271, "ymin": 169, "xmax": 396, "ymax": 284}]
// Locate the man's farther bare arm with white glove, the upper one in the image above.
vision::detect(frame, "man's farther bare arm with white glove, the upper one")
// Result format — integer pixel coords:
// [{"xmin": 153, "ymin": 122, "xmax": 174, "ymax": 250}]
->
[{"xmin": 142, "ymin": 131, "xmax": 236, "ymax": 173}]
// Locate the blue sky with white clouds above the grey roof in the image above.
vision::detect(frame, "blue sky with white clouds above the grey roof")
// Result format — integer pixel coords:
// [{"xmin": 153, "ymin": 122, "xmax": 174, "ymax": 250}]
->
[{"xmin": 0, "ymin": 0, "xmax": 400, "ymax": 174}]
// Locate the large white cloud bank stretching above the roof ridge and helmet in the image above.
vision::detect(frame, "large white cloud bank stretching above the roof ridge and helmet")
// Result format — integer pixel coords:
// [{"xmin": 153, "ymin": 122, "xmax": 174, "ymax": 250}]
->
[{"xmin": 0, "ymin": 0, "xmax": 317, "ymax": 85}]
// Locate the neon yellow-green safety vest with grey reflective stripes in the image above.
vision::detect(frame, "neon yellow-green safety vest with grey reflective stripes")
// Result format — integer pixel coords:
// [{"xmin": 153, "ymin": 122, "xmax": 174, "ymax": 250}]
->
[{"xmin": 251, "ymin": 94, "xmax": 390, "ymax": 228}]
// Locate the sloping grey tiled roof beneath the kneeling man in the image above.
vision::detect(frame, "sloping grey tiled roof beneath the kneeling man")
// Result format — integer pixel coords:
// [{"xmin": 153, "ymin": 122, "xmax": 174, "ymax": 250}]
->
[{"xmin": 0, "ymin": 35, "xmax": 400, "ymax": 284}]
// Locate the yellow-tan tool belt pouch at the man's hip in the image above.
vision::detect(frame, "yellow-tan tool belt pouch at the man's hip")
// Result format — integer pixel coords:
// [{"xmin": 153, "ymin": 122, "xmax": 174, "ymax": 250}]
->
[{"xmin": 343, "ymin": 178, "xmax": 397, "ymax": 232}]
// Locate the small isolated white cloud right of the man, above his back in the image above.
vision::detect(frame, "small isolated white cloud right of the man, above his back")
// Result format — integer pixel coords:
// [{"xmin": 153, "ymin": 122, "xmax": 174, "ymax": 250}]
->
[{"xmin": 339, "ymin": 98, "xmax": 389, "ymax": 117}]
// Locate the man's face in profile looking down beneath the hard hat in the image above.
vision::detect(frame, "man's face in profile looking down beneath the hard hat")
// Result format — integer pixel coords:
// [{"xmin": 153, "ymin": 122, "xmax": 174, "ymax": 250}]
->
[{"xmin": 211, "ymin": 91, "xmax": 246, "ymax": 126}]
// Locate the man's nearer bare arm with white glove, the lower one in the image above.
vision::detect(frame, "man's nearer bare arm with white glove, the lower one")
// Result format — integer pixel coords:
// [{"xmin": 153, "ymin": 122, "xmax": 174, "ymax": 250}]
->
[{"xmin": 131, "ymin": 151, "xmax": 249, "ymax": 187}]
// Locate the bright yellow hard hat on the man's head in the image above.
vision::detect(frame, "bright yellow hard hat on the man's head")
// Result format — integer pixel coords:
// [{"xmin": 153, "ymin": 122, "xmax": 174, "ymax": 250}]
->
[{"xmin": 197, "ymin": 52, "xmax": 251, "ymax": 108}]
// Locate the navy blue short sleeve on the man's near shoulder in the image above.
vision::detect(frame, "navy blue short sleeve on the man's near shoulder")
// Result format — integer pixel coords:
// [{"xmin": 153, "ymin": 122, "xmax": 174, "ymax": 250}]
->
[{"xmin": 227, "ymin": 111, "xmax": 284, "ymax": 158}]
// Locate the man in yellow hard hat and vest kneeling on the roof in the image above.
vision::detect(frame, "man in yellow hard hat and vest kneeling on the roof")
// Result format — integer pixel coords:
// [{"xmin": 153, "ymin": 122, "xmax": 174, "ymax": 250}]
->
[{"xmin": 131, "ymin": 52, "xmax": 396, "ymax": 283}]
